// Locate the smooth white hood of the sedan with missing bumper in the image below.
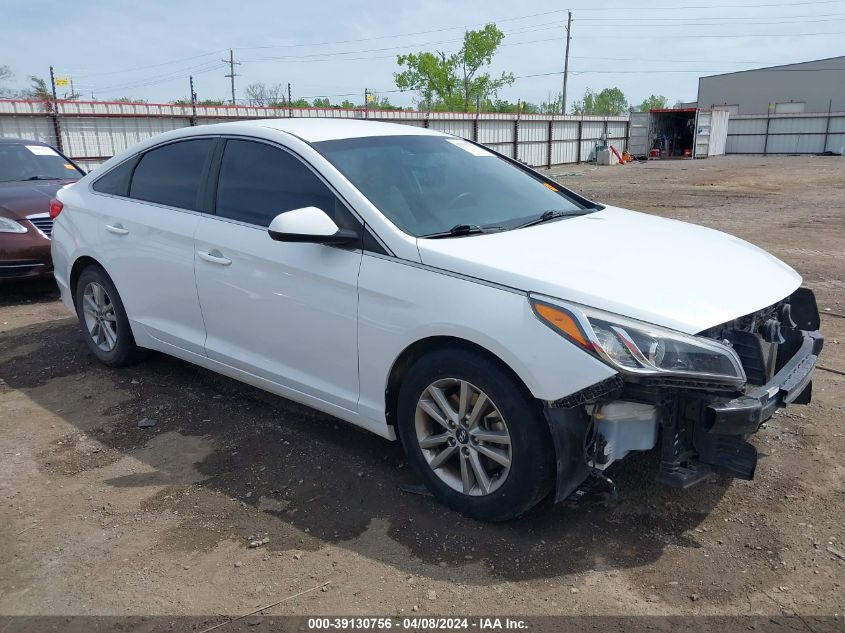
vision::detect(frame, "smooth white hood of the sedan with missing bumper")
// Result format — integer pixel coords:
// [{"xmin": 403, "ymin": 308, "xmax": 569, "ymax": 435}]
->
[{"xmin": 417, "ymin": 207, "xmax": 801, "ymax": 334}]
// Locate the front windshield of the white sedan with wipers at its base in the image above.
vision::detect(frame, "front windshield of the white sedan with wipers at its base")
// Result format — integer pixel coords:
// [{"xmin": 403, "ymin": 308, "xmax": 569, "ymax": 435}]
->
[{"xmin": 314, "ymin": 135, "xmax": 584, "ymax": 237}]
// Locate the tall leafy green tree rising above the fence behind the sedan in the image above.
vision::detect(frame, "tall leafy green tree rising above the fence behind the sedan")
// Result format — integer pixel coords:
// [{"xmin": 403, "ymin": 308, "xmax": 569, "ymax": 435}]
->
[{"xmin": 394, "ymin": 24, "xmax": 514, "ymax": 112}]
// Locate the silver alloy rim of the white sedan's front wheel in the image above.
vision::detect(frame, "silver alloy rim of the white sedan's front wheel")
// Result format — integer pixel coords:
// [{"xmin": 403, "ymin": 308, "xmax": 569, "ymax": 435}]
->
[{"xmin": 415, "ymin": 378, "xmax": 513, "ymax": 496}]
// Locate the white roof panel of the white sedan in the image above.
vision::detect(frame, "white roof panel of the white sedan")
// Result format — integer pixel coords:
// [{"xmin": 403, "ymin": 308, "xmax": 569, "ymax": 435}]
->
[{"xmin": 203, "ymin": 117, "xmax": 447, "ymax": 143}]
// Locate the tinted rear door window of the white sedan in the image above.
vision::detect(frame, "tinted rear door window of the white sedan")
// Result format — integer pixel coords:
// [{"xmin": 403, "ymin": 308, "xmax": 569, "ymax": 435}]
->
[{"xmin": 129, "ymin": 139, "xmax": 214, "ymax": 210}]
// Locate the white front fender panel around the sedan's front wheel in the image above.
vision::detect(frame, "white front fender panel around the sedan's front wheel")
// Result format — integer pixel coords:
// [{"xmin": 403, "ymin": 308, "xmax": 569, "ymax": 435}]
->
[{"xmin": 358, "ymin": 256, "xmax": 615, "ymax": 432}]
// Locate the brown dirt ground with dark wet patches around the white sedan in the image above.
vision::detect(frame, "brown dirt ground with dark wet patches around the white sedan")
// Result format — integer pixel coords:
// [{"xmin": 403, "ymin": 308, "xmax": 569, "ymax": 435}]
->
[{"xmin": 0, "ymin": 157, "xmax": 845, "ymax": 615}]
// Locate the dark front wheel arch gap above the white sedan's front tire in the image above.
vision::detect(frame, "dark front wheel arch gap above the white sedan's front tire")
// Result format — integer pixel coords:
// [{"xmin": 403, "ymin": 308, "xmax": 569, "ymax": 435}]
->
[{"xmin": 384, "ymin": 335, "xmax": 539, "ymax": 426}]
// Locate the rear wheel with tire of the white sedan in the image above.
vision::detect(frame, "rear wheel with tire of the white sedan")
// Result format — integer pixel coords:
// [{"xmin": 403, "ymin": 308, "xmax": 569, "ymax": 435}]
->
[{"xmin": 74, "ymin": 265, "xmax": 143, "ymax": 367}]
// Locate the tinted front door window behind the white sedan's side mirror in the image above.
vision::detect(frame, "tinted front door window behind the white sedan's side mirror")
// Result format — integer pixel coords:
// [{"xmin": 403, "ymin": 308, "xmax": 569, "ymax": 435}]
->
[{"xmin": 217, "ymin": 140, "xmax": 344, "ymax": 228}]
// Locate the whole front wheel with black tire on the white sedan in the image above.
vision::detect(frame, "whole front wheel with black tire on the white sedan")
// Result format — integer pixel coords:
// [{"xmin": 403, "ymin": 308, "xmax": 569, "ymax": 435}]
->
[{"xmin": 398, "ymin": 349, "xmax": 555, "ymax": 521}]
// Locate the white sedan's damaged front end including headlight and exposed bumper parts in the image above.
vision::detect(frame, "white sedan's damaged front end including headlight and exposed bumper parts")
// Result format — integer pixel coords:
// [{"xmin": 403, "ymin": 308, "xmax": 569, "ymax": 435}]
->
[{"xmin": 531, "ymin": 288, "xmax": 824, "ymax": 501}]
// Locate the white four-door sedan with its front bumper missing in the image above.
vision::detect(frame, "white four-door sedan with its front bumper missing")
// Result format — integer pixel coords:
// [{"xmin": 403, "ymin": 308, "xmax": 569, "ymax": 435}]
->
[{"xmin": 51, "ymin": 119, "xmax": 823, "ymax": 521}]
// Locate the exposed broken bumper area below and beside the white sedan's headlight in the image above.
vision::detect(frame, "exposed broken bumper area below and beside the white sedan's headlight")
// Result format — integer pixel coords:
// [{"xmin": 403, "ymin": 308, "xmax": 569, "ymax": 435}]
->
[{"xmin": 545, "ymin": 289, "xmax": 824, "ymax": 501}]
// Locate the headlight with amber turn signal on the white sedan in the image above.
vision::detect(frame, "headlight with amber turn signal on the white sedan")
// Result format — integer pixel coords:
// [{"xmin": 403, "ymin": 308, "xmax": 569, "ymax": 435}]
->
[{"xmin": 529, "ymin": 297, "xmax": 745, "ymax": 387}]
